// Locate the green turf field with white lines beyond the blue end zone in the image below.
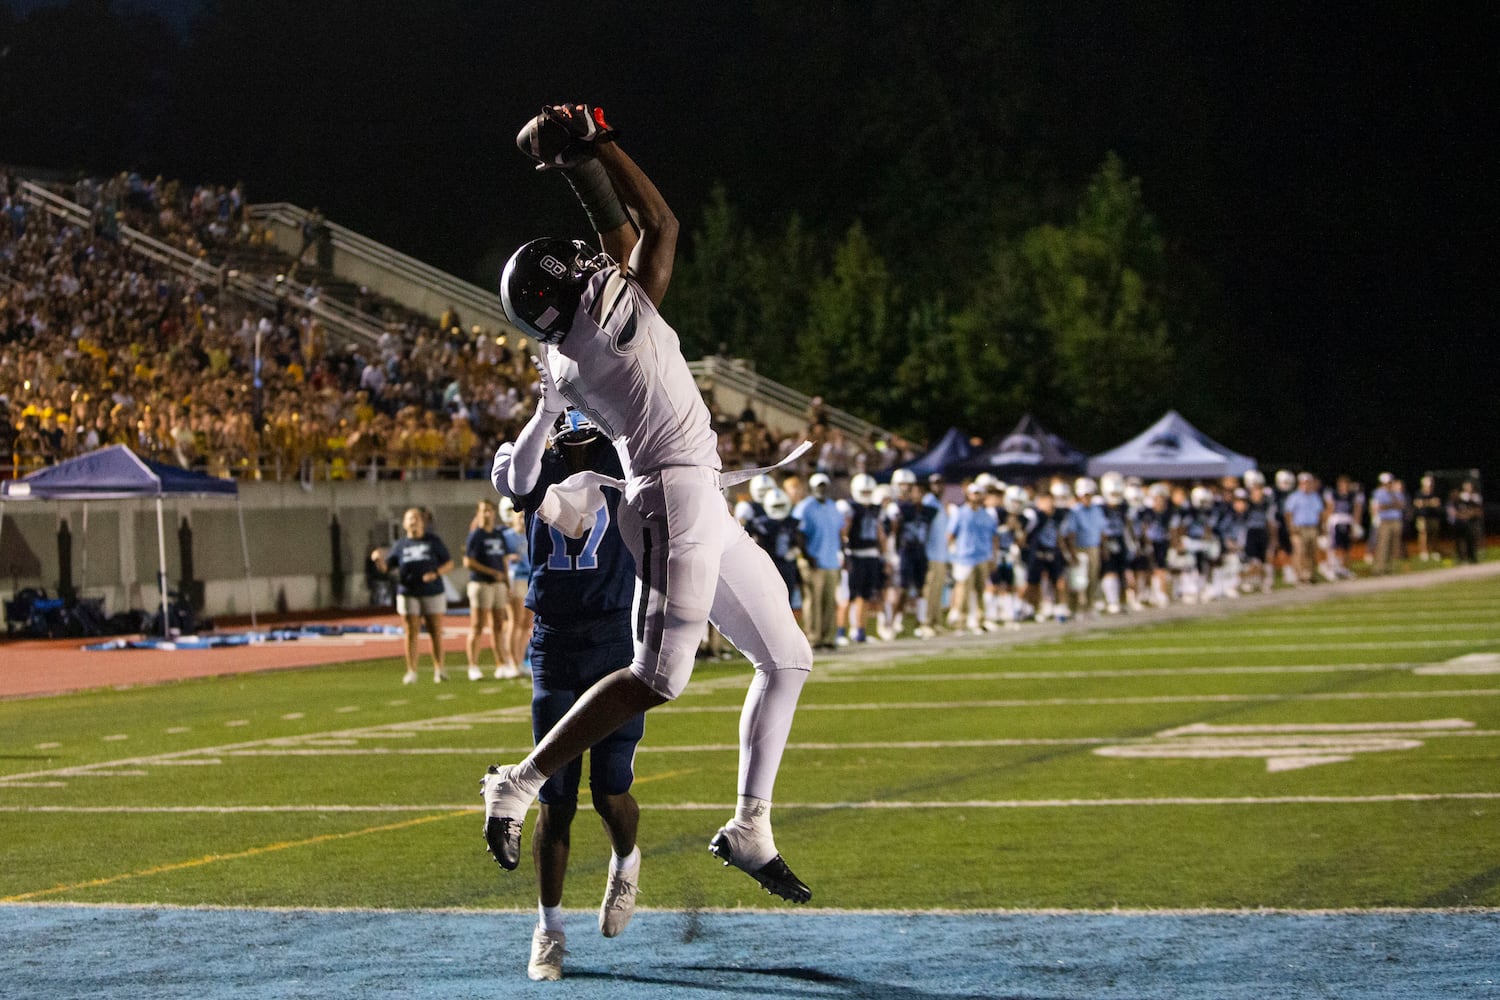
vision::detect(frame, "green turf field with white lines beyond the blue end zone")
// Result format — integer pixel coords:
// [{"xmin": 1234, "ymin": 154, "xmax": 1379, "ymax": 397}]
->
[{"xmin": 0, "ymin": 579, "xmax": 1500, "ymax": 910}]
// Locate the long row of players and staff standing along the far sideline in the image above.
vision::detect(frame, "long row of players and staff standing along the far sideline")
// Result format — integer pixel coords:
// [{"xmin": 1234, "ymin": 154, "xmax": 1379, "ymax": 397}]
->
[{"xmin": 735, "ymin": 469, "xmax": 1484, "ymax": 648}]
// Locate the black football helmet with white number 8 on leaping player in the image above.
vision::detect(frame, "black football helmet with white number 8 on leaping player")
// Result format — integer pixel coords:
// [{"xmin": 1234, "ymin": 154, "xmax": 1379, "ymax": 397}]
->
[{"xmin": 500, "ymin": 237, "xmax": 614, "ymax": 343}]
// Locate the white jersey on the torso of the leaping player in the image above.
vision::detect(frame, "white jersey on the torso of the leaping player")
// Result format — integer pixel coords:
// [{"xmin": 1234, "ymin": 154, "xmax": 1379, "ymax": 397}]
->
[{"xmin": 545, "ymin": 267, "xmax": 720, "ymax": 478}]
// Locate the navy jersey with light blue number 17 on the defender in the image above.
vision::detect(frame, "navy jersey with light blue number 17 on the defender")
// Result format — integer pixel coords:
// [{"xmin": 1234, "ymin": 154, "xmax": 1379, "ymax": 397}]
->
[{"xmin": 518, "ymin": 441, "xmax": 636, "ymax": 631}]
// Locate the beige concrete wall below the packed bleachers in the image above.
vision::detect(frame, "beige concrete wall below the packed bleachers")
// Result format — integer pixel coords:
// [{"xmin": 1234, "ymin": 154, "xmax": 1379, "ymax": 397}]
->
[{"xmin": 0, "ymin": 480, "xmax": 497, "ymax": 626}]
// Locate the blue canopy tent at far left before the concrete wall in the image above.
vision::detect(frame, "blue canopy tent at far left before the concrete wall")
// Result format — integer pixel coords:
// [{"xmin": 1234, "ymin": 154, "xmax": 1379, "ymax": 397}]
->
[{"xmin": 0, "ymin": 444, "xmax": 255, "ymax": 630}]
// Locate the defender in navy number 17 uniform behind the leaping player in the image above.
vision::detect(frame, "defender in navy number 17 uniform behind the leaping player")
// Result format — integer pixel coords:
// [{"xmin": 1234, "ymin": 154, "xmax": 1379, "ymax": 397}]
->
[{"xmin": 492, "ymin": 409, "xmax": 645, "ymax": 979}]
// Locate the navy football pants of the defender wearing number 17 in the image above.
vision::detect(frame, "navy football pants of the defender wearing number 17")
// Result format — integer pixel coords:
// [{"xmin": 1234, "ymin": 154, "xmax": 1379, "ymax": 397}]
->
[{"xmin": 531, "ymin": 609, "xmax": 647, "ymax": 805}]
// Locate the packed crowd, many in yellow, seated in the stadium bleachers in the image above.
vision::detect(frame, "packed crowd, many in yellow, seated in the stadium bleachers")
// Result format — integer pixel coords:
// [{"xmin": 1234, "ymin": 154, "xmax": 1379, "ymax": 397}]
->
[{"xmin": 0, "ymin": 175, "xmax": 555, "ymax": 478}]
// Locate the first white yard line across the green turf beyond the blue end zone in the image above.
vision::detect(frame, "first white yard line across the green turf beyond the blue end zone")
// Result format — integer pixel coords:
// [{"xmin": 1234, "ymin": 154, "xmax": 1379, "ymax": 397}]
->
[{"xmin": 11, "ymin": 792, "xmax": 1500, "ymax": 815}]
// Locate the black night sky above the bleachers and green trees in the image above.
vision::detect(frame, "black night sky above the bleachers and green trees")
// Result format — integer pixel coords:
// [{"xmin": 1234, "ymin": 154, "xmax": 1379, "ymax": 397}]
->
[{"xmin": 0, "ymin": 0, "xmax": 1500, "ymax": 492}]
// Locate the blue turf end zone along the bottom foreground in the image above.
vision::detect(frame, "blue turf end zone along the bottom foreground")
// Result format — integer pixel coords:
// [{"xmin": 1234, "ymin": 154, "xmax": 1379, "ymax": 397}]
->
[{"xmin": 0, "ymin": 904, "xmax": 1500, "ymax": 1000}]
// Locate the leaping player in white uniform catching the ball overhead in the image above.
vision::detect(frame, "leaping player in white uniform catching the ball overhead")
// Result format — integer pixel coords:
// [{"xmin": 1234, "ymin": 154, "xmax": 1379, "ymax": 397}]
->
[{"xmin": 483, "ymin": 105, "xmax": 813, "ymax": 903}]
